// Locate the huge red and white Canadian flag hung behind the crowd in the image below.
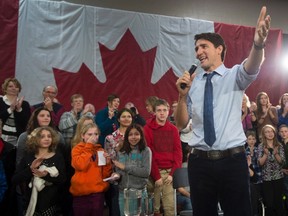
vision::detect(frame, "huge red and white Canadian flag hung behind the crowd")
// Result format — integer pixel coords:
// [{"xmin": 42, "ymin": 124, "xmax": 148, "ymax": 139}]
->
[{"xmin": 0, "ymin": 0, "xmax": 287, "ymax": 118}]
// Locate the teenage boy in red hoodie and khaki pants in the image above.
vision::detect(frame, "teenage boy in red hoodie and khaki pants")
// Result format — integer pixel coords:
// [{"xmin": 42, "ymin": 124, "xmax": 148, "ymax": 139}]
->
[{"xmin": 144, "ymin": 99, "xmax": 182, "ymax": 216}]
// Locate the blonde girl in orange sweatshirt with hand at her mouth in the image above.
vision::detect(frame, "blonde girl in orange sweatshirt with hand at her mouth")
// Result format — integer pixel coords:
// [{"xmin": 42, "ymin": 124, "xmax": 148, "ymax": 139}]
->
[{"xmin": 70, "ymin": 123, "xmax": 112, "ymax": 216}]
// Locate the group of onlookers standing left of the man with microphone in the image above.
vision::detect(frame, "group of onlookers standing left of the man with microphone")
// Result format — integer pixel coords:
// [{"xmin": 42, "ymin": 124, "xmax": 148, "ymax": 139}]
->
[{"xmin": 0, "ymin": 78, "xmax": 182, "ymax": 216}]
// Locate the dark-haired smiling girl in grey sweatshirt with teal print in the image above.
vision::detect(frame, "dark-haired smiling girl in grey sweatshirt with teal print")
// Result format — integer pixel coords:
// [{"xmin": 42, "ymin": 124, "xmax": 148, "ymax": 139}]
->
[{"xmin": 113, "ymin": 124, "xmax": 151, "ymax": 215}]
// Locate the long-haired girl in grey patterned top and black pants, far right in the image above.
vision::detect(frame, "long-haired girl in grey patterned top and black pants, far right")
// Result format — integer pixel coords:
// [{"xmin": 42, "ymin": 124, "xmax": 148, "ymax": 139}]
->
[{"xmin": 258, "ymin": 125, "xmax": 285, "ymax": 216}]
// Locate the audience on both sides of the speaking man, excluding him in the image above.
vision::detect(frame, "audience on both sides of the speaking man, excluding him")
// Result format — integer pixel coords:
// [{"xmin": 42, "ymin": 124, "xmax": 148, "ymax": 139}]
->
[{"xmin": 0, "ymin": 78, "xmax": 288, "ymax": 215}]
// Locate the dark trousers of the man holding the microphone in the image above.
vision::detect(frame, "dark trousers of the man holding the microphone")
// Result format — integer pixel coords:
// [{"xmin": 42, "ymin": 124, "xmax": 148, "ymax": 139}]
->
[{"xmin": 188, "ymin": 153, "xmax": 251, "ymax": 216}]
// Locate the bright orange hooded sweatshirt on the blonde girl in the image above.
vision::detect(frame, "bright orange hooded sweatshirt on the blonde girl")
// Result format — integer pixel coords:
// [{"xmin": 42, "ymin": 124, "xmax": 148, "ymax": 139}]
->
[{"xmin": 70, "ymin": 142, "xmax": 112, "ymax": 196}]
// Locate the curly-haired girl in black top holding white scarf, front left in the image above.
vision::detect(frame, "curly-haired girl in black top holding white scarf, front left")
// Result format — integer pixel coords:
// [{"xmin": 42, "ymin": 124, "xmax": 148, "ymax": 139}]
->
[{"xmin": 12, "ymin": 126, "xmax": 65, "ymax": 216}]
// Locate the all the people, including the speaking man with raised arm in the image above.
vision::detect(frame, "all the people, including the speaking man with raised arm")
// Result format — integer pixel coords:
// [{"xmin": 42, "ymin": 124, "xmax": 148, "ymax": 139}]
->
[{"xmin": 0, "ymin": 7, "xmax": 288, "ymax": 216}]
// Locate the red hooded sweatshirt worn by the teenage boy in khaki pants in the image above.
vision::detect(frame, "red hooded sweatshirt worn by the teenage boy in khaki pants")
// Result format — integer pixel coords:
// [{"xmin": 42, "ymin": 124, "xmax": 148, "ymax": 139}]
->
[{"xmin": 144, "ymin": 117, "xmax": 182, "ymax": 181}]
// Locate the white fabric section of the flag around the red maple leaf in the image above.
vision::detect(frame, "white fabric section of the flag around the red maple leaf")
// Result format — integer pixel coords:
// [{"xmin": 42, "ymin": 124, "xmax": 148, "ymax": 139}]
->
[{"xmin": 16, "ymin": 0, "xmax": 214, "ymax": 104}]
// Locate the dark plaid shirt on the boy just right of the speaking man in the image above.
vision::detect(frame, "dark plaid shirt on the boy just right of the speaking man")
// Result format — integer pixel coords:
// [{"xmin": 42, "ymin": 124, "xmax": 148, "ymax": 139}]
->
[{"xmin": 246, "ymin": 146, "xmax": 263, "ymax": 184}]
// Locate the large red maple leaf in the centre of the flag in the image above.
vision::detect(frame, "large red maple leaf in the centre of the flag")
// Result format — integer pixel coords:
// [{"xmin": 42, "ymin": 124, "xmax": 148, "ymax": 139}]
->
[{"xmin": 53, "ymin": 29, "xmax": 177, "ymax": 117}]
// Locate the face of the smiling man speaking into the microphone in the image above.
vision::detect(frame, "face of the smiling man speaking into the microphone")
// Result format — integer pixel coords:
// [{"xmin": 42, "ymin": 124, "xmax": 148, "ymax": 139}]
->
[{"xmin": 195, "ymin": 39, "xmax": 223, "ymax": 72}]
